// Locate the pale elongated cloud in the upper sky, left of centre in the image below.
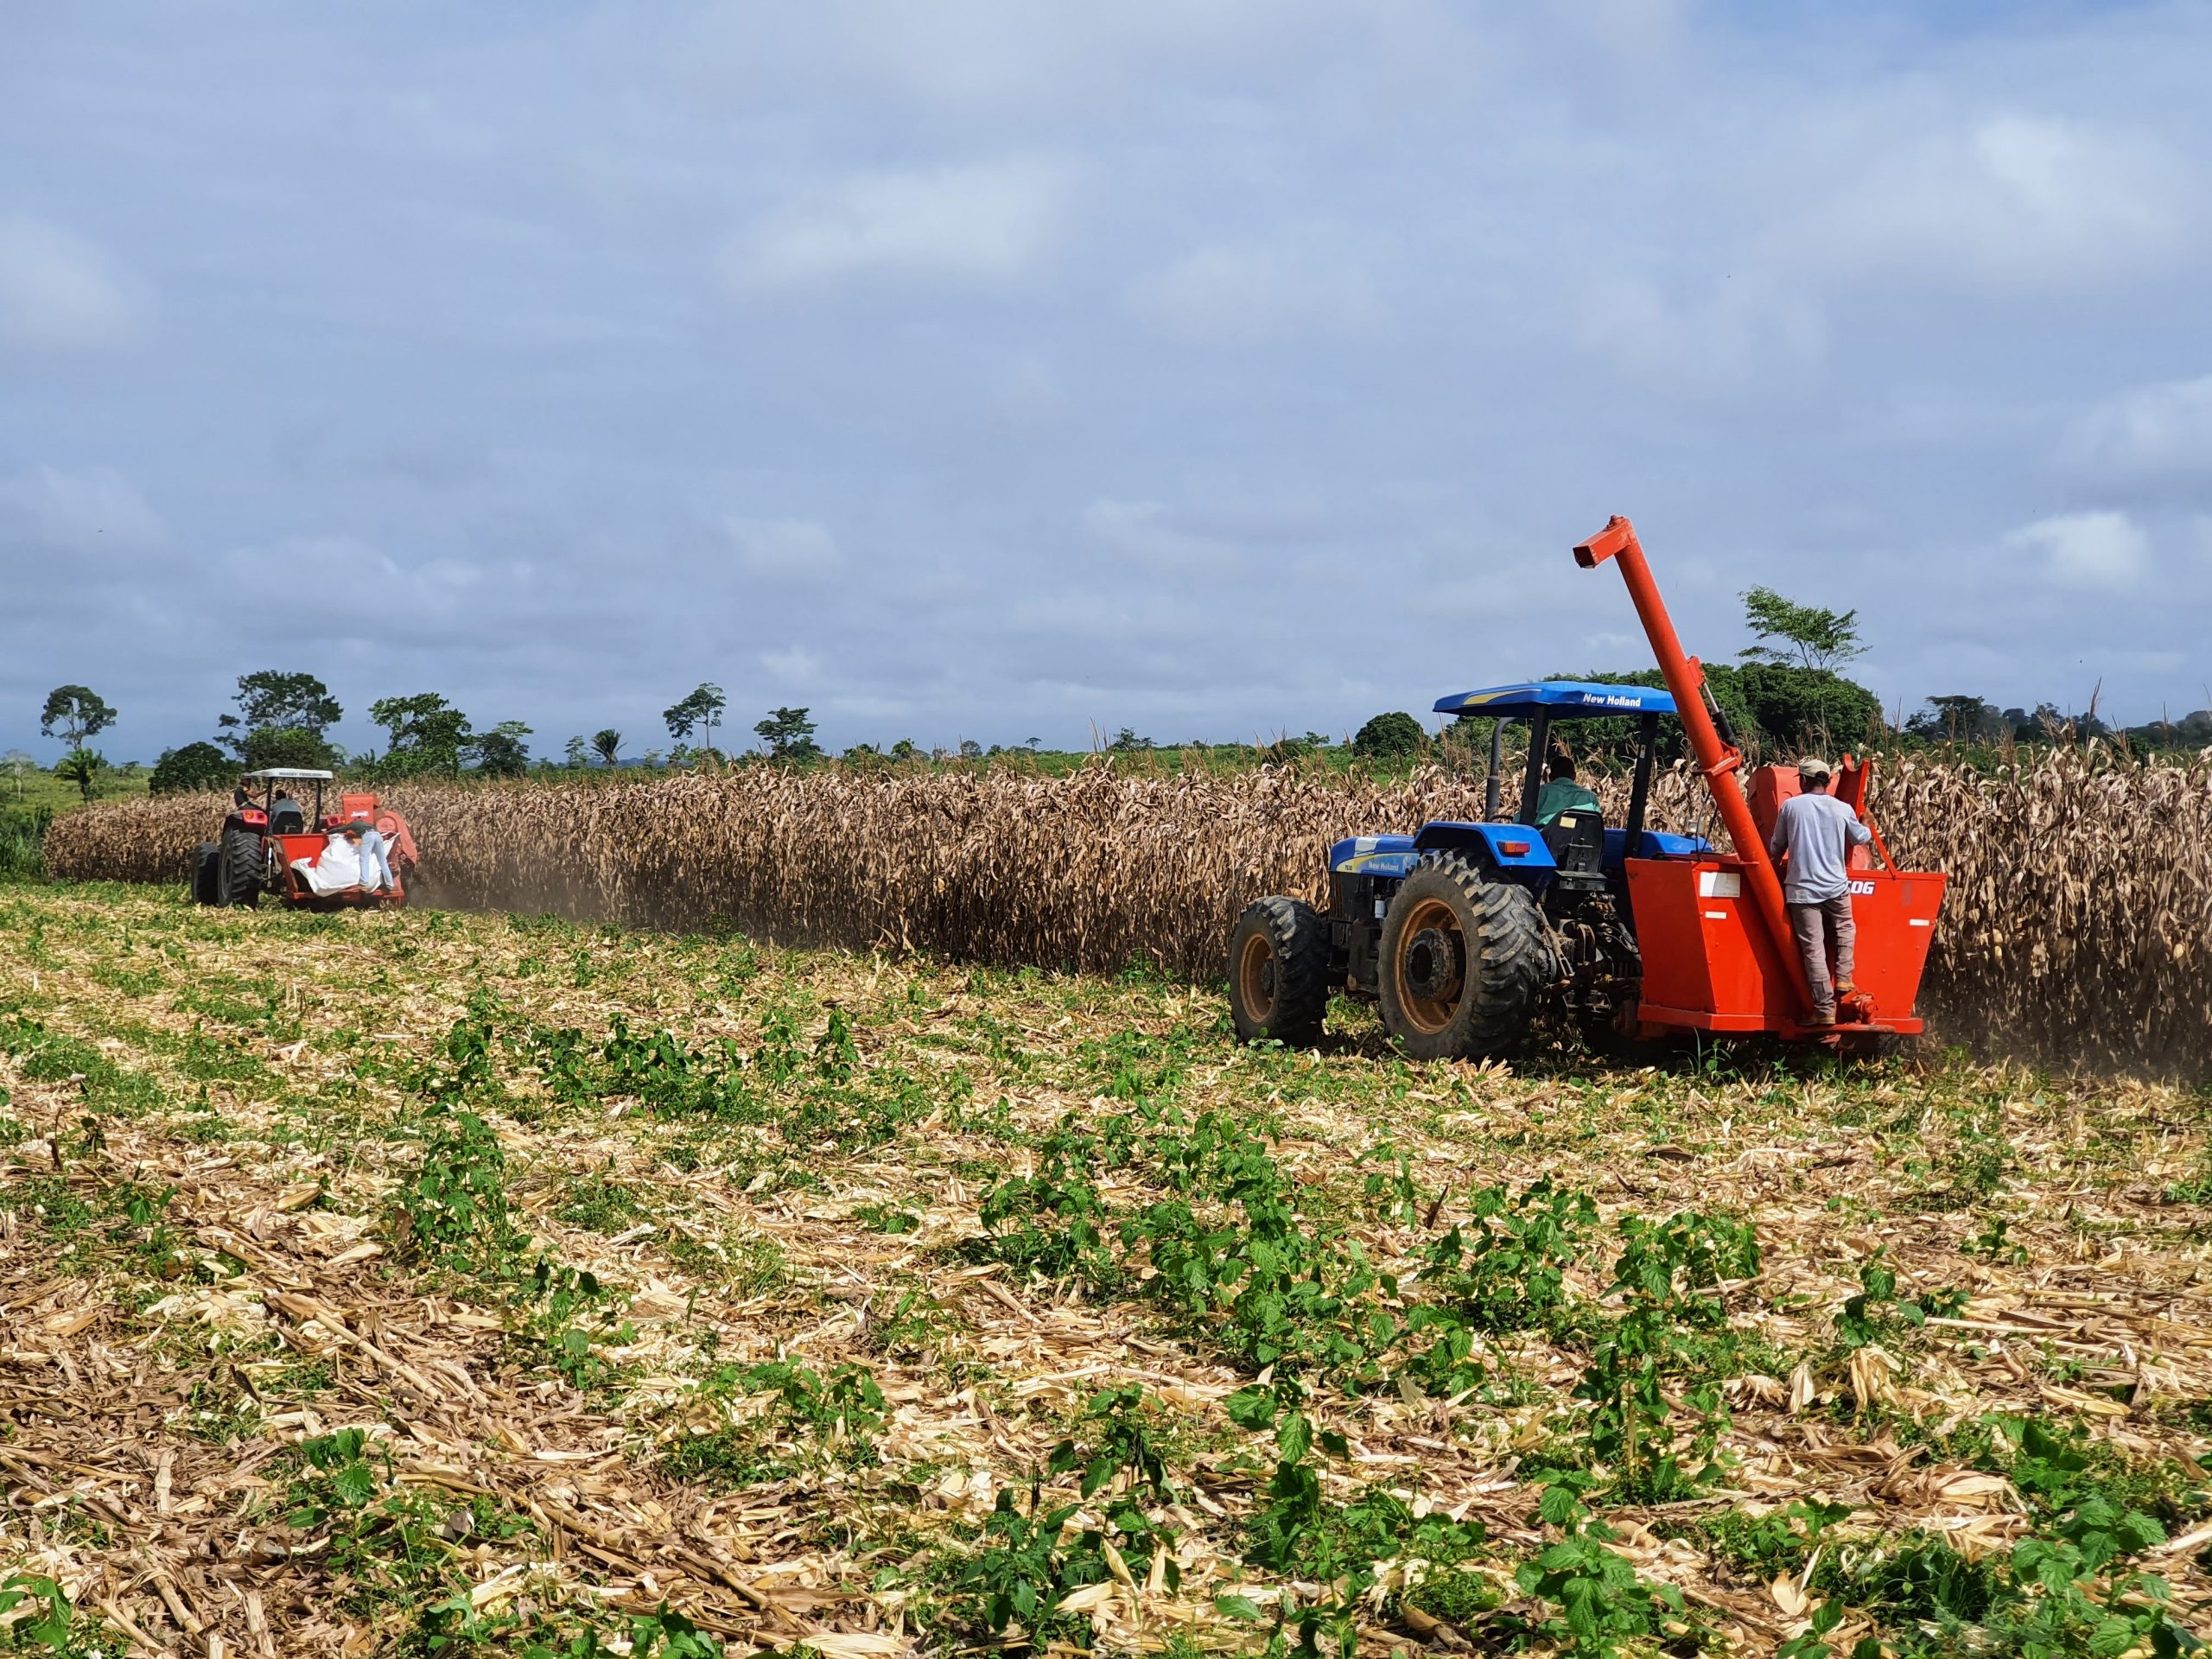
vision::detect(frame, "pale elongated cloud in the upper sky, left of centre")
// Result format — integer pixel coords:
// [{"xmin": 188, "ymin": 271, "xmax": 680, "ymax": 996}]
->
[{"xmin": 723, "ymin": 159, "xmax": 1068, "ymax": 289}]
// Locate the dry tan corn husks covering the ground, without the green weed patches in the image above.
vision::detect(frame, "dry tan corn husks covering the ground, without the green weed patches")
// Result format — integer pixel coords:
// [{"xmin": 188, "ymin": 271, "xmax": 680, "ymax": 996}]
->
[{"xmin": 0, "ymin": 887, "xmax": 2212, "ymax": 1659}]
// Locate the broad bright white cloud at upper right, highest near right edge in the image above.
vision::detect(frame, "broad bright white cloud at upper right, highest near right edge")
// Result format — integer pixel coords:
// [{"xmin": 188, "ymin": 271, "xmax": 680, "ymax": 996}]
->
[{"xmin": 1774, "ymin": 115, "xmax": 2203, "ymax": 289}]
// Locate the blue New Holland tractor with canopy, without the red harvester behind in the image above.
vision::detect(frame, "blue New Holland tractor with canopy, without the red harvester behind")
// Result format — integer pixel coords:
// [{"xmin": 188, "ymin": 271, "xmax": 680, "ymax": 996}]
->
[{"xmin": 1228, "ymin": 679, "xmax": 1710, "ymax": 1059}]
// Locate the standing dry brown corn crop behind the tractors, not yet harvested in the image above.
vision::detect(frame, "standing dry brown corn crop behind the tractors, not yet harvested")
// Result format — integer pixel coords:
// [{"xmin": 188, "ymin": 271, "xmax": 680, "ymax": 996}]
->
[{"xmin": 47, "ymin": 747, "xmax": 2212, "ymax": 1073}]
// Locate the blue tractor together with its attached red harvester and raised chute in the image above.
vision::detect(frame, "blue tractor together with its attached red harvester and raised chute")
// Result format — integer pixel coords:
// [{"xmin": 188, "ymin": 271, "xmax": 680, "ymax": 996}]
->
[{"xmin": 1228, "ymin": 518, "xmax": 1944, "ymax": 1059}]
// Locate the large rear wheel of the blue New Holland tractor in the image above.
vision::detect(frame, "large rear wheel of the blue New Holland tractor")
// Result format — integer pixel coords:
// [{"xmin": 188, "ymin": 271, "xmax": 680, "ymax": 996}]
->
[{"xmin": 1376, "ymin": 858, "xmax": 1557, "ymax": 1059}]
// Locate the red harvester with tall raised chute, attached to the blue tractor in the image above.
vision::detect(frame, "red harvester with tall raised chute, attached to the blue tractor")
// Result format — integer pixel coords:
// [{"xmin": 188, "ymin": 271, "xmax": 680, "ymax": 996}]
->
[{"xmin": 1575, "ymin": 515, "xmax": 1944, "ymax": 1046}]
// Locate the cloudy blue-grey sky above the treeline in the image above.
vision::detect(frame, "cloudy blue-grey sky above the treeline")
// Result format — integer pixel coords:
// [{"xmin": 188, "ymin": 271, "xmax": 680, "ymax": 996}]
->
[{"xmin": 0, "ymin": 0, "xmax": 2212, "ymax": 759}]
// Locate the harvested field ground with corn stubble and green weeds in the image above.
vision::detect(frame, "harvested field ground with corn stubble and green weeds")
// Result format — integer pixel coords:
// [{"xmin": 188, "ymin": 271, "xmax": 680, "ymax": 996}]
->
[{"xmin": 0, "ymin": 889, "xmax": 2212, "ymax": 1659}]
